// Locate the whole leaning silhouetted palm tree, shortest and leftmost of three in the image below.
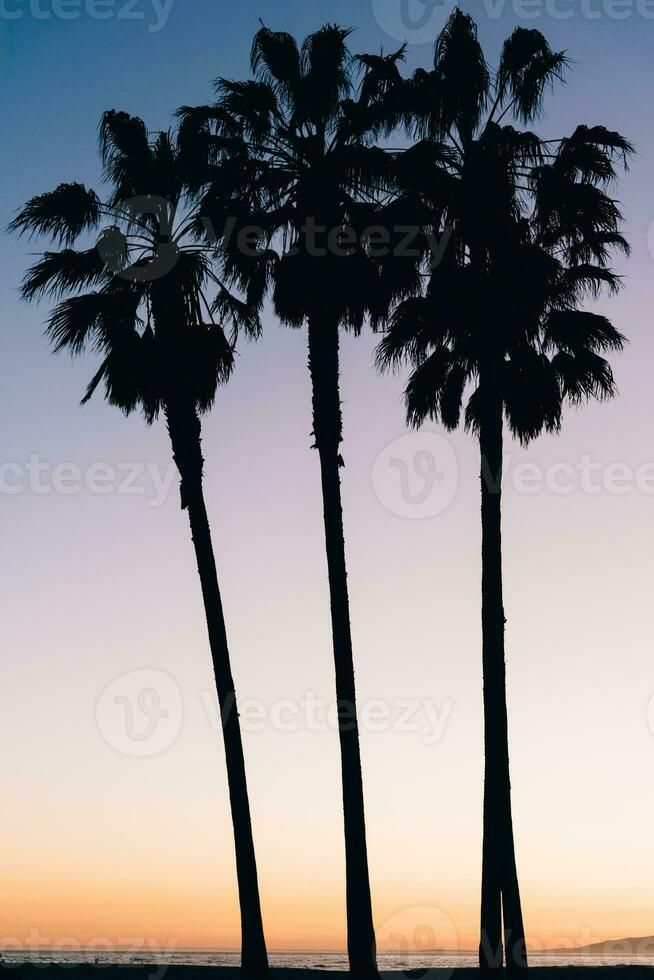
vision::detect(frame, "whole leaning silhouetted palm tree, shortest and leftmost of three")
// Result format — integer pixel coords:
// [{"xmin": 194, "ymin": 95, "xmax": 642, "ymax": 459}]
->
[{"xmin": 12, "ymin": 111, "xmax": 268, "ymax": 980}]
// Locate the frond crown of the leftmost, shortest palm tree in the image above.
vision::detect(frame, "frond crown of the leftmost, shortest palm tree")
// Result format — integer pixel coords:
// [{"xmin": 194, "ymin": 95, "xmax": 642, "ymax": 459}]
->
[{"xmin": 12, "ymin": 111, "xmax": 258, "ymax": 422}]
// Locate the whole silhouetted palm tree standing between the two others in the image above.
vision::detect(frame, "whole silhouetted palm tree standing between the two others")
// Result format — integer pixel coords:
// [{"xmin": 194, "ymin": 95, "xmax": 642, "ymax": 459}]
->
[{"xmin": 180, "ymin": 25, "xmax": 416, "ymax": 977}]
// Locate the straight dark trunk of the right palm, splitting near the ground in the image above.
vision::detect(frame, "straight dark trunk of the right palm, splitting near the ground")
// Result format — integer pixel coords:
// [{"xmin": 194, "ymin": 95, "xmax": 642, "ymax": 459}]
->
[{"xmin": 479, "ymin": 396, "xmax": 527, "ymax": 973}]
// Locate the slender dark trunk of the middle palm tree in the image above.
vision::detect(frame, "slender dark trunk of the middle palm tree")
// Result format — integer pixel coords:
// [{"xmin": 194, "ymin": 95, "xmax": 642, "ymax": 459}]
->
[{"xmin": 309, "ymin": 316, "xmax": 378, "ymax": 980}]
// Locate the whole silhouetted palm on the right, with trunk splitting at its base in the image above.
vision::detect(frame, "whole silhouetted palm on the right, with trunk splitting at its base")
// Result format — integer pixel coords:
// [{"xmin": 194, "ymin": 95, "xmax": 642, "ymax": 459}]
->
[{"xmin": 378, "ymin": 10, "xmax": 631, "ymax": 971}]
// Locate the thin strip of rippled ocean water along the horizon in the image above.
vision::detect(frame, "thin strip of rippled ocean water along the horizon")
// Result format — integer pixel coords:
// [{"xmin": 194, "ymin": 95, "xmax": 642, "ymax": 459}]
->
[{"xmin": 1, "ymin": 949, "xmax": 654, "ymax": 980}]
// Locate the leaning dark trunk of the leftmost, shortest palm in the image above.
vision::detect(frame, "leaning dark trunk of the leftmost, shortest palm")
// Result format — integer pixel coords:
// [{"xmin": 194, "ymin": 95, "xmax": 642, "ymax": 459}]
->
[{"xmin": 166, "ymin": 403, "xmax": 268, "ymax": 980}]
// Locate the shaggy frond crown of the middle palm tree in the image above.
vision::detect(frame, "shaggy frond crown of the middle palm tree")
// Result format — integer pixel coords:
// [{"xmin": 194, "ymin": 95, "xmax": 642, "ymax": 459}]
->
[{"xmin": 180, "ymin": 25, "xmax": 416, "ymax": 348}]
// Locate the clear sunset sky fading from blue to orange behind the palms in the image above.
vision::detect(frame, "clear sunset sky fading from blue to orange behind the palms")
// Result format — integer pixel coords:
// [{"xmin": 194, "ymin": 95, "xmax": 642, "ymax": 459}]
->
[{"xmin": 0, "ymin": 0, "xmax": 654, "ymax": 950}]
